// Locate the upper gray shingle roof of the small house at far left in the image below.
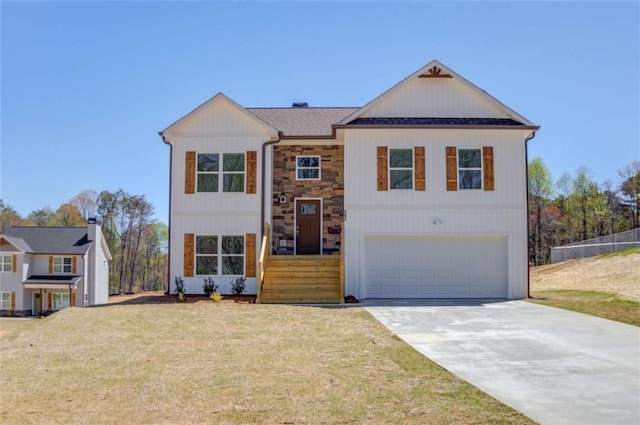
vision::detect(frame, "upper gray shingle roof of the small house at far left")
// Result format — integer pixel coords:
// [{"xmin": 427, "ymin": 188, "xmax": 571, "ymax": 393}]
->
[{"xmin": 4, "ymin": 226, "xmax": 93, "ymax": 254}]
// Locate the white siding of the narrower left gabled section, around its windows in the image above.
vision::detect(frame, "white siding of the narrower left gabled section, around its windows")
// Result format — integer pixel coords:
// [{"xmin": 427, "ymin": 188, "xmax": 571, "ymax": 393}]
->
[{"xmin": 169, "ymin": 102, "xmax": 274, "ymax": 294}]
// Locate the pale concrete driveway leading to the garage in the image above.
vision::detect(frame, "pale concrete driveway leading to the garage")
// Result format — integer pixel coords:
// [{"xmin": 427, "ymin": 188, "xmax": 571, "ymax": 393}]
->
[{"xmin": 363, "ymin": 300, "xmax": 640, "ymax": 425}]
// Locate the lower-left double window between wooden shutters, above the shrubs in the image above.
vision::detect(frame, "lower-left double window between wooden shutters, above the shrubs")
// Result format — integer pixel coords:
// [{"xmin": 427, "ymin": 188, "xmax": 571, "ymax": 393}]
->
[{"xmin": 195, "ymin": 235, "xmax": 244, "ymax": 276}]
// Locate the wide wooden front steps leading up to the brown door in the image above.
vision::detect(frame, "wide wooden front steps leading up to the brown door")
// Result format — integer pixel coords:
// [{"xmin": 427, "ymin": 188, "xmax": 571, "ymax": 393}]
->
[{"xmin": 260, "ymin": 255, "xmax": 344, "ymax": 304}]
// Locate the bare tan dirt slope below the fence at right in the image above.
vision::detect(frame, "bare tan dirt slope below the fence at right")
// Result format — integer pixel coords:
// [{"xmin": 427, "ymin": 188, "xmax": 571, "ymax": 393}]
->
[{"xmin": 531, "ymin": 252, "xmax": 640, "ymax": 302}]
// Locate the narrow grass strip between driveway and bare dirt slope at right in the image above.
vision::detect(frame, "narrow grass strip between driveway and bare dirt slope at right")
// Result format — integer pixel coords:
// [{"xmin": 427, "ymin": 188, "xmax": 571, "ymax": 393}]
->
[{"xmin": 528, "ymin": 290, "xmax": 640, "ymax": 326}]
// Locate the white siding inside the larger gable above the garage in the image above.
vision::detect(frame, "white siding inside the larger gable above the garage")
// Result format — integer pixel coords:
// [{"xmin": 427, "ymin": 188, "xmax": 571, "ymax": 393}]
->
[{"xmin": 361, "ymin": 78, "xmax": 509, "ymax": 118}]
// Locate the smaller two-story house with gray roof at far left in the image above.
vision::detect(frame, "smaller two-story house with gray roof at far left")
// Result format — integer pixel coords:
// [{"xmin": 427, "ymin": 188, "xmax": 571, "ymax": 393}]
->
[{"xmin": 0, "ymin": 220, "xmax": 111, "ymax": 316}]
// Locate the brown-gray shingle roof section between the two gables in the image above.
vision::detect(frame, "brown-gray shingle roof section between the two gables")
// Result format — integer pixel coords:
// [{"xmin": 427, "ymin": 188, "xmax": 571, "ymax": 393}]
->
[{"xmin": 246, "ymin": 108, "xmax": 360, "ymax": 137}]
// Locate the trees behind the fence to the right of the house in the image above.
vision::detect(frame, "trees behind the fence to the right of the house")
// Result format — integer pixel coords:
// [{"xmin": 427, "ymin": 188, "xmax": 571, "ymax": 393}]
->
[{"xmin": 528, "ymin": 157, "xmax": 640, "ymax": 265}]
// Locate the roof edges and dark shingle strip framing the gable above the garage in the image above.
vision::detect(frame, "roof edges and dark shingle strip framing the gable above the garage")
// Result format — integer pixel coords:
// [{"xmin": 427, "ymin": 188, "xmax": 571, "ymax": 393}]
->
[{"xmin": 337, "ymin": 60, "xmax": 539, "ymax": 129}]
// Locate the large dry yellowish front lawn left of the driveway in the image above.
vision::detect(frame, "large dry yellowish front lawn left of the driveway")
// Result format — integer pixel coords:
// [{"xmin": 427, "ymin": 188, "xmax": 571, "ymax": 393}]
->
[{"xmin": 0, "ymin": 303, "xmax": 532, "ymax": 424}]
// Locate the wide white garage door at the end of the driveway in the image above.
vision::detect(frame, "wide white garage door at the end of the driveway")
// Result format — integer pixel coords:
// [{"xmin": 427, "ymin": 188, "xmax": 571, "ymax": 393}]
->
[{"xmin": 365, "ymin": 236, "xmax": 508, "ymax": 298}]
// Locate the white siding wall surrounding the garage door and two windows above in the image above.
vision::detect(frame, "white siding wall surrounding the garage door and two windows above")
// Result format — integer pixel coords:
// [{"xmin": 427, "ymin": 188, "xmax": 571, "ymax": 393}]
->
[{"xmin": 345, "ymin": 130, "xmax": 527, "ymax": 298}]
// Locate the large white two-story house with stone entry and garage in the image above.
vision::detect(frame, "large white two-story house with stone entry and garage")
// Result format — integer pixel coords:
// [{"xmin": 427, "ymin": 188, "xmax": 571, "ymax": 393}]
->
[{"xmin": 160, "ymin": 61, "xmax": 539, "ymax": 302}]
